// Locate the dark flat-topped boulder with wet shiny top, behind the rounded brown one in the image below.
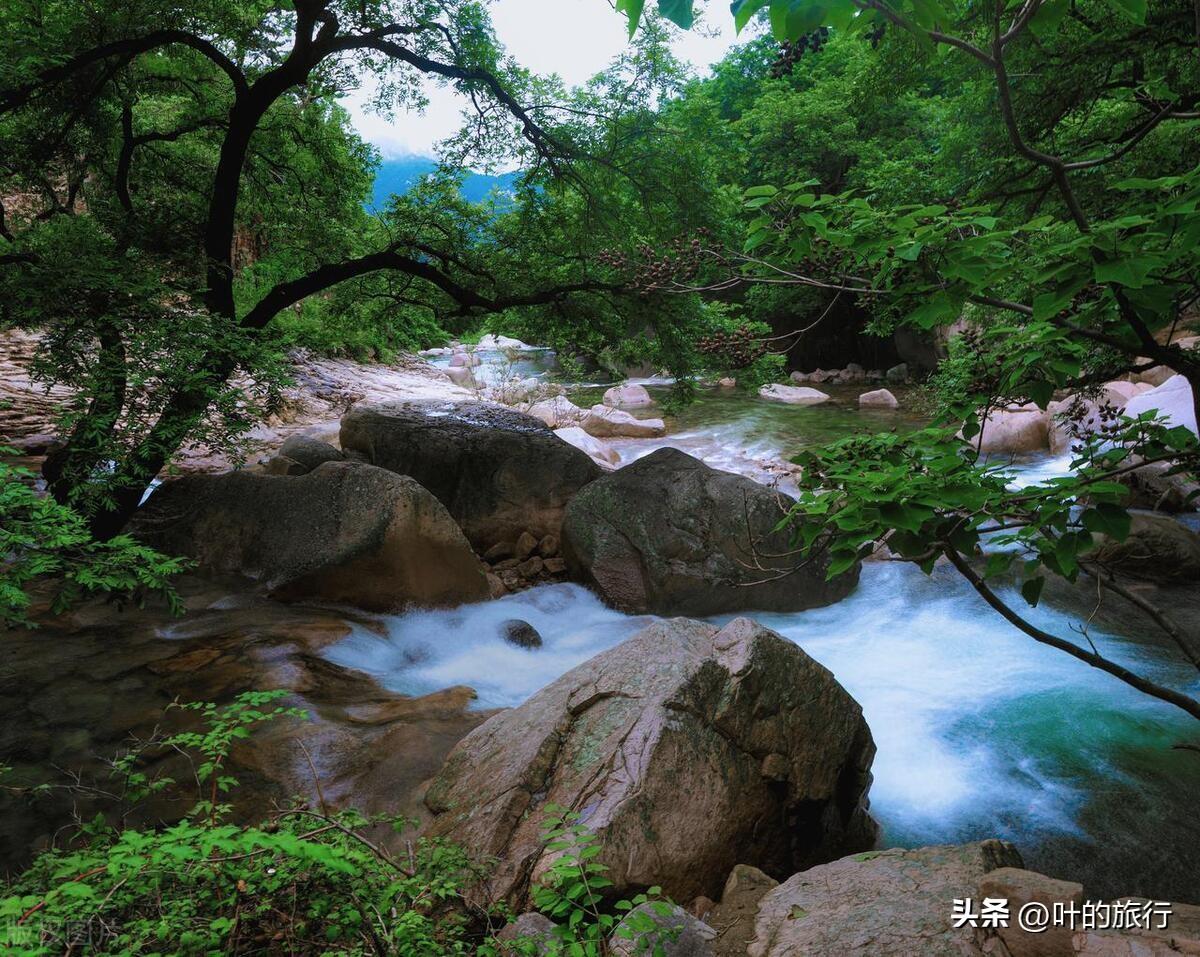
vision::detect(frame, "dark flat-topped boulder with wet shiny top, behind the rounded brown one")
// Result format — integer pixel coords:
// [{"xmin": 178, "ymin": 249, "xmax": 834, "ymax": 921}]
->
[{"xmin": 341, "ymin": 402, "xmax": 600, "ymax": 552}]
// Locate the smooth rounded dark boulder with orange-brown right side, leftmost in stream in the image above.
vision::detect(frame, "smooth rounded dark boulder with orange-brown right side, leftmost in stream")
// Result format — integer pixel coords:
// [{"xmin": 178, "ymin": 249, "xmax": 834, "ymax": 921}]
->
[{"xmin": 130, "ymin": 462, "xmax": 488, "ymax": 612}]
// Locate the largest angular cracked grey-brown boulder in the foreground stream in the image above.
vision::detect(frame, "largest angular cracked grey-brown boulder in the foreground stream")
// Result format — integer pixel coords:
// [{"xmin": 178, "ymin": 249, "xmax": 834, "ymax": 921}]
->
[{"xmin": 426, "ymin": 619, "xmax": 876, "ymax": 907}]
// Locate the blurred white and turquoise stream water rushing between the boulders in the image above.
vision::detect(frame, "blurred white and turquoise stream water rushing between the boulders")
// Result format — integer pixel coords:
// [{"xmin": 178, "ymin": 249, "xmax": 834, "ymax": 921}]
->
[{"xmin": 329, "ymin": 371, "xmax": 1200, "ymax": 901}]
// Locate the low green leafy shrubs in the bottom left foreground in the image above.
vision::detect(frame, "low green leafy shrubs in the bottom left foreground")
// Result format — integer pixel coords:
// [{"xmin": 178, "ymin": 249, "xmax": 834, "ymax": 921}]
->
[{"xmin": 0, "ymin": 692, "xmax": 671, "ymax": 957}]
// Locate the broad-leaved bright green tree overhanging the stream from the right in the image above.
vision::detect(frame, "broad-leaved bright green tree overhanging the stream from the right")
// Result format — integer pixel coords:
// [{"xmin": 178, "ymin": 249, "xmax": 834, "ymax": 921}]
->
[{"xmin": 619, "ymin": 0, "xmax": 1200, "ymax": 718}]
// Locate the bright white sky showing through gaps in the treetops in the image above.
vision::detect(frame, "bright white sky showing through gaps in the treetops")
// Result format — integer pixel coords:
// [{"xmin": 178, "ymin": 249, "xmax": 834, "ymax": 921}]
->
[{"xmin": 343, "ymin": 0, "xmax": 734, "ymax": 160}]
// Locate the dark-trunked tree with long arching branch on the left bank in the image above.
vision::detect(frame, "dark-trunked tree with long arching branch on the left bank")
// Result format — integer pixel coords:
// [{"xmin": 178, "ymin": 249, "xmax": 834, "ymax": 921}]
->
[{"xmin": 0, "ymin": 0, "xmax": 633, "ymax": 538}]
